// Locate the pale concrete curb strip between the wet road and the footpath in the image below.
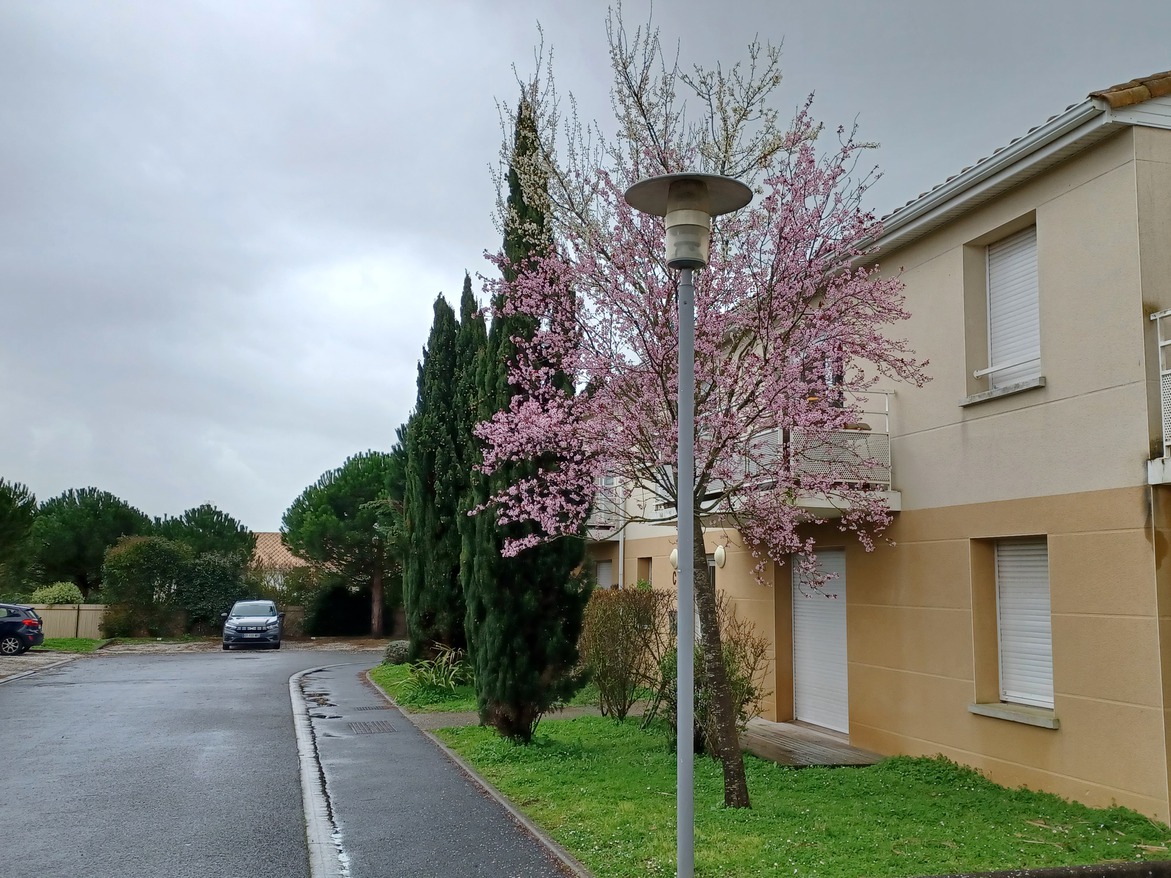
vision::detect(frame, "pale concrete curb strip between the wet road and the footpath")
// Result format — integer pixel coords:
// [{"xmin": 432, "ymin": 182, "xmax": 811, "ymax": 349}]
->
[{"xmin": 289, "ymin": 665, "xmax": 348, "ymax": 878}]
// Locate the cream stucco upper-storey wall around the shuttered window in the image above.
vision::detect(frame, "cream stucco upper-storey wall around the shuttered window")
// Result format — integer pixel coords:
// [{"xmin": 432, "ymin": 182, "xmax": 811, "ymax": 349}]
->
[{"xmin": 882, "ymin": 132, "xmax": 1156, "ymax": 509}]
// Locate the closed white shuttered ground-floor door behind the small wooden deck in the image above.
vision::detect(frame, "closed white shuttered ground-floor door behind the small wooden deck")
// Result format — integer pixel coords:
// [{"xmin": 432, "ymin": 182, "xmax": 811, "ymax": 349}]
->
[{"xmin": 793, "ymin": 549, "xmax": 850, "ymax": 733}]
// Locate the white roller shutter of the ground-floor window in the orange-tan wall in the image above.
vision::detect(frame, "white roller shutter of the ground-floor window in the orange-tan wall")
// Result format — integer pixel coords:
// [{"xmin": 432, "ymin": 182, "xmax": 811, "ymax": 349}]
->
[{"xmin": 997, "ymin": 537, "xmax": 1053, "ymax": 707}]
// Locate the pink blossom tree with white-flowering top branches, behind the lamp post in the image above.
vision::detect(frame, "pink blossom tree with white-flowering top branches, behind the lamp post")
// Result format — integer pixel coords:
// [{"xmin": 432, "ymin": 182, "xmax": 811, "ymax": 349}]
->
[{"xmin": 478, "ymin": 16, "xmax": 924, "ymax": 807}]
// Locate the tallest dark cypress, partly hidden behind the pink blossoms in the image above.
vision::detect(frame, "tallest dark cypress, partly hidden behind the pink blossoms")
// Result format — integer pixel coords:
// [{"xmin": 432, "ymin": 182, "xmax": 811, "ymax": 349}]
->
[{"xmin": 464, "ymin": 97, "xmax": 589, "ymax": 742}]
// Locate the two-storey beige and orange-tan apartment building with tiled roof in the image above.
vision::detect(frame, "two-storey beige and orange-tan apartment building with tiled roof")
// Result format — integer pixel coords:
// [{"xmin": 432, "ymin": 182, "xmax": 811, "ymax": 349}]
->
[{"xmin": 591, "ymin": 73, "xmax": 1171, "ymax": 821}]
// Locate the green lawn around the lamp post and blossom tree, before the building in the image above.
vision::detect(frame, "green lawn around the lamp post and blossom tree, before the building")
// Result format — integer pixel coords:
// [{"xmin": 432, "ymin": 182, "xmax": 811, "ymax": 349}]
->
[{"xmin": 438, "ymin": 716, "xmax": 1171, "ymax": 878}]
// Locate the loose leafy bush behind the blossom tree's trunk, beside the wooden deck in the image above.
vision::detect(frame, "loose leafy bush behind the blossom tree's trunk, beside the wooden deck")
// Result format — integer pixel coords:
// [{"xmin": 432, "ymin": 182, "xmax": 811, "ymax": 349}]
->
[{"xmin": 643, "ymin": 594, "xmax": 768, "ymax": 755}]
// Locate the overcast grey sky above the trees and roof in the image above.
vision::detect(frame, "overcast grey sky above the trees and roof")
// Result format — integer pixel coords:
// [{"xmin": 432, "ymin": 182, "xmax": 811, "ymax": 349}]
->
[{"xmin": 0, "ymin": 0, "xmax": 1171, "ymax": 530}]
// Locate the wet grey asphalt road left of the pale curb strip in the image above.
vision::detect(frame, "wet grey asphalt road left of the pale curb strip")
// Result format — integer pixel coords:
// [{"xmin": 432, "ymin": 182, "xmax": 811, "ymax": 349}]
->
[{"xmin": 0, "ymin": 650, "xmax": 377, "ymax": 878}]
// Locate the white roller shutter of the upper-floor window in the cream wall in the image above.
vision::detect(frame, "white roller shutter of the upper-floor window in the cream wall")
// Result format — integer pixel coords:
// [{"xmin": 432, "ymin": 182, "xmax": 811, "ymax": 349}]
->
[{"xmin": 988, "ymin": 226, "xmax": 1041, "ymax": 387}]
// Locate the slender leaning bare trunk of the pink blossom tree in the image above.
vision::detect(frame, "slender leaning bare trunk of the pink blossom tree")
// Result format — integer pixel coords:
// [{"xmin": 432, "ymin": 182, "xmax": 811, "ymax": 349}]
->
[{"xmin": 679, "ymin": 516, "xmax": 752, "ymax": 808}]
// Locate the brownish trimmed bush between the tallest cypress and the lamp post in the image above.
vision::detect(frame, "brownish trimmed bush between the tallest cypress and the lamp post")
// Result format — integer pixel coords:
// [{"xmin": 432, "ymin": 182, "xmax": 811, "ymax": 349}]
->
[{"xmin": 578, "ymin": 589, "xmax": 671, "ymax": 720}]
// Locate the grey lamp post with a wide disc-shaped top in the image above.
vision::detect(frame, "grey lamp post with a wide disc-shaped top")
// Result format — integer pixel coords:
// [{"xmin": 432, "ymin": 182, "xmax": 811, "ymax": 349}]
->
[{"xmin": 625, "ymin": 173, "xmax": 752, "ymax": 878}]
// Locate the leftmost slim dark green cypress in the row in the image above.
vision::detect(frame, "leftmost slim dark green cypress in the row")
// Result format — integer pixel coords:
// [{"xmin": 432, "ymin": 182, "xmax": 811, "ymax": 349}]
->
[{"xmin": 403, "ymin": 296, "xmax": 466, "ymax": 656}]
